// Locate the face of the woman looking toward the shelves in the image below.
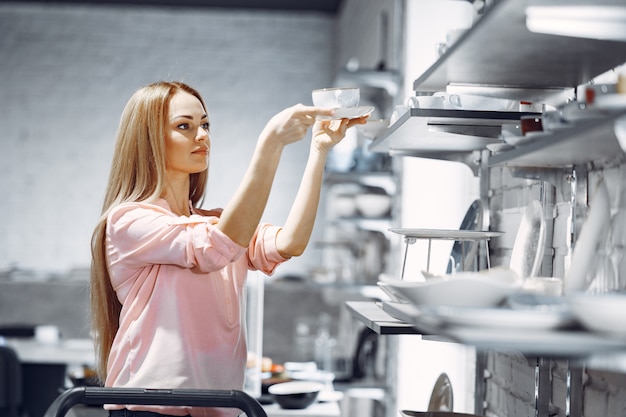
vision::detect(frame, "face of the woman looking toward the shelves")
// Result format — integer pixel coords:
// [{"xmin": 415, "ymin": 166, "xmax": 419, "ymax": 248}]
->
[{"xmin": 165, "ymin": 92, "xmax": 210, "ymax": 175}]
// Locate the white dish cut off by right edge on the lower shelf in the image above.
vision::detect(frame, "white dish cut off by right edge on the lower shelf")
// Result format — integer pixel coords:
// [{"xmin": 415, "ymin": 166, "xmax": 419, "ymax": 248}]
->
[{"xmin": 567, "ymin": 292, "xmax": 626, "ymax": 338}]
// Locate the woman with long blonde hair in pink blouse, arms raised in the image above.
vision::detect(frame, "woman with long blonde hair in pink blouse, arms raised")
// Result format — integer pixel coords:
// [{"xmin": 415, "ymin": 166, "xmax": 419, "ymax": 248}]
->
[{"xmin": 91, "ymin": 82, "xmax": 366, "ymax": 417}]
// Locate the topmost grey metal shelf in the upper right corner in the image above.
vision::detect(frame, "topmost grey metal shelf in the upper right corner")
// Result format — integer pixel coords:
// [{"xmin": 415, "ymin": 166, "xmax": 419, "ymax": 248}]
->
[{"xmin": 413, "ymin": 0, "xmax": 626, "ymax": 102}]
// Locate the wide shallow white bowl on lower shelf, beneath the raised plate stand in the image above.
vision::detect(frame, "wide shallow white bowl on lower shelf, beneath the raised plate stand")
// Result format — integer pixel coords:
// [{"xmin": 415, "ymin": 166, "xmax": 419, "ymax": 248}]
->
[{"xmin": 381, "ymin": 267, "xmax": 521, "ymax": 307}]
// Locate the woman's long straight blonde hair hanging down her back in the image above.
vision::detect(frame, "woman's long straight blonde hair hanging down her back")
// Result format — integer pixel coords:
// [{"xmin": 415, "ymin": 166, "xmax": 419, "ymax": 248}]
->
[{"xmin": 90, "ymin": 81, "xmax": 208, "ymax": 382}]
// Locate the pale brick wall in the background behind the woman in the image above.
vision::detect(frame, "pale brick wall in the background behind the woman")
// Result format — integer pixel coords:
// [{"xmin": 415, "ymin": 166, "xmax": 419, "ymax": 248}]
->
[{"xmin": 0, "ymin": 3, "xmax": 335, "ymax": 273}]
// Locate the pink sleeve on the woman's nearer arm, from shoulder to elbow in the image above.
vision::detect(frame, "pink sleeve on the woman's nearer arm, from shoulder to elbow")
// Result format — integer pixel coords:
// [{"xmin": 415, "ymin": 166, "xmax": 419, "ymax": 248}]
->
[{"xmin": 107, "ymin": 203, "xmax": 245, "ymax": 272}]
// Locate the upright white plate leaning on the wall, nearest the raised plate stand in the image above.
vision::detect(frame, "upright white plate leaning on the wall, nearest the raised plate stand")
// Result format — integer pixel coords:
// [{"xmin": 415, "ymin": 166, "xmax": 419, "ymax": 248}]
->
[{"xmin": 509, "ymin": 200, "xmax": 546, "ymax": 278}]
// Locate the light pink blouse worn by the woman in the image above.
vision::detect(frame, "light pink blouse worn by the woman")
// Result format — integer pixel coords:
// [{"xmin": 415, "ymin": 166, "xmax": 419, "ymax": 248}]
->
[{"xmin": 105, "ymin": 199, "xmax": 286, "ymax": 416}]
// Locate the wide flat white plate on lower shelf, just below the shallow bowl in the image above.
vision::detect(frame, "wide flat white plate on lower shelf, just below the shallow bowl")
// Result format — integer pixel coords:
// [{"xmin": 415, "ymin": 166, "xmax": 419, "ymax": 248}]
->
[{"xmin": 420, "ymin": 307, "xmax": 575, "ymax": 330}]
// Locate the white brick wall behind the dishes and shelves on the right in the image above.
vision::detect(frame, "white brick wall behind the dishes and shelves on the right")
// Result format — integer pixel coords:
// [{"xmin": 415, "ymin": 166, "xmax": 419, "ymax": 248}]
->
[{"xmin": 485, "ymin": 160, "xmax": 626, "ymax": 417}]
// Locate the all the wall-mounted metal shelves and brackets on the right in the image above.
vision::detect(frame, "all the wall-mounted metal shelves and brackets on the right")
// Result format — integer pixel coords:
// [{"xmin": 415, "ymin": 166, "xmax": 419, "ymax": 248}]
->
[{"xmin": 348, "ymin": 0, "xmax": 626, "ymax": 417}]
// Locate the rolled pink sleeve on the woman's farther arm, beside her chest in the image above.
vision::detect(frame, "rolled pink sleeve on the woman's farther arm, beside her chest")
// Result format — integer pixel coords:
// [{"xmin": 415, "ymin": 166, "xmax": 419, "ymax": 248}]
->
[{"xmin": 248, "ymin": 223, "xmax": 288, "ymax": 275}]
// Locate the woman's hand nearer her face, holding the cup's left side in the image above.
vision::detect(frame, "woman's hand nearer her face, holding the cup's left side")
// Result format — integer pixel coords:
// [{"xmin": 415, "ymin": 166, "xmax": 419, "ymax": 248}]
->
[{"xmin": 260, "ymin": 104, "xmax": 333, "ymax": 146}]
